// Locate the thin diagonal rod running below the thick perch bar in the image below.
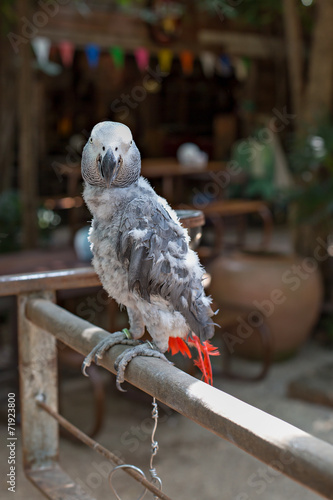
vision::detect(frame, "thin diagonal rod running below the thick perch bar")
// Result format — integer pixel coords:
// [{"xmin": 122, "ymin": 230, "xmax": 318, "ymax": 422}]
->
[{"xmin": 36, "ymin": 400, "xmax": 171, "ymax": 500}]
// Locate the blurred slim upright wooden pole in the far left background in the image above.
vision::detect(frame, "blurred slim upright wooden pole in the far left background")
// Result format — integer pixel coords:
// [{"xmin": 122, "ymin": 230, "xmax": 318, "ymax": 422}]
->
[{"xmin": 17, "ymin": 0, "xmax": 38, "ymax": 248}]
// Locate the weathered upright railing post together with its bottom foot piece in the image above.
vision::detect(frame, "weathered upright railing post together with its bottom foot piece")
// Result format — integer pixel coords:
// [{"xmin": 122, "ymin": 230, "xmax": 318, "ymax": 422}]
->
[{"xmin": 18, "ymin": 292, "xmax": 95, "ymax": 500}]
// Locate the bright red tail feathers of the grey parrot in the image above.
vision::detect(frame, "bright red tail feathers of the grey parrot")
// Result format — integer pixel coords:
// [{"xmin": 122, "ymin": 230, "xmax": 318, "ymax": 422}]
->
[{"xmin": 169, "ymin": 333, "xmax": 220, "ymax": 385}]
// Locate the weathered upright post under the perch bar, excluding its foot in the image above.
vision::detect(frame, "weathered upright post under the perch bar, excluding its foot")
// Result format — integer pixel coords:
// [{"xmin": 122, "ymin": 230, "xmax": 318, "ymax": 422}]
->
[{"xmin": 18, "ymin": 292, "xmax": 59, "ymax": 470}]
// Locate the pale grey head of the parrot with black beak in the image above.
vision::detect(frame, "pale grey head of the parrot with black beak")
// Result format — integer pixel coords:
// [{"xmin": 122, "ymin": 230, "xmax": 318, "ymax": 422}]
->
[{"xmin": 81, "ymin": 122, "xmax": 141, "ymax": 188}]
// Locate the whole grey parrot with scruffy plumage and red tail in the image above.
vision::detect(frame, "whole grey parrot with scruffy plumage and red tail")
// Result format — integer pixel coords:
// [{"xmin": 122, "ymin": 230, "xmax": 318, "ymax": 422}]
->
[{"xmin": 81, "ymin": 121, "xmax": 215, "ymax": 388}]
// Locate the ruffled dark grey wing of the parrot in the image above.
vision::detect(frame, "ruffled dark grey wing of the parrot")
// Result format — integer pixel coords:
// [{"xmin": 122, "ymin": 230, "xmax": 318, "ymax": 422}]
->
[{"xmin": 117, "ymin": 198, "xmax": 214, "ymax": 341}]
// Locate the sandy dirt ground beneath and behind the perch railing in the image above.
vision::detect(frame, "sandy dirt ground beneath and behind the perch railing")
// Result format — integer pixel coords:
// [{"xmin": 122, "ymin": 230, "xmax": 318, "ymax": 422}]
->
[{"xmin": 0, "ymin": 344, "xmax": 333, "ymax": 500}]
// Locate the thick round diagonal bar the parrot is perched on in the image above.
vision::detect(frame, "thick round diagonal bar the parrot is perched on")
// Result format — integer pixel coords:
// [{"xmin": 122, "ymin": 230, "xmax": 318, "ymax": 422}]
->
[{"xmin": 26, "ymin": 299, "xmax": 333, "ymax": 499}]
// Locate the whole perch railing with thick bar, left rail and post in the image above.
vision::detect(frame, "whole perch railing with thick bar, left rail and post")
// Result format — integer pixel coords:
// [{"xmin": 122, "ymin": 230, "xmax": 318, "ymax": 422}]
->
[{"xmin": 0, "ymin": 268, "xmax": 333, "ymax": 500}]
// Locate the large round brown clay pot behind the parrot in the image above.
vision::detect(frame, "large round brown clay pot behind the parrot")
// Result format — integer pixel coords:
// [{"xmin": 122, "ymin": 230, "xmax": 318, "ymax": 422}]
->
[{"xmin": 208, "ymin": 252, "xmax": 323, "ymax": 359}]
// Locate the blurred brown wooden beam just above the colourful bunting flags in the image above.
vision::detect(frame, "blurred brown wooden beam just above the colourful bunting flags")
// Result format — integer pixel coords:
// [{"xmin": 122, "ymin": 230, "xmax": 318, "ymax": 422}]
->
[{"xmin": 39, "ymin": 5, "xmax": 285, "ymax": 59}]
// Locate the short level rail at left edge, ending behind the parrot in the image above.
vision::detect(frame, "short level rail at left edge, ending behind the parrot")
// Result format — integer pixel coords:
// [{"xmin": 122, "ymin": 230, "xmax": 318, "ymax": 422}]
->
[{"xmin": 0, "ymin": 267, "xmax": 101, "ymax": 297}]
